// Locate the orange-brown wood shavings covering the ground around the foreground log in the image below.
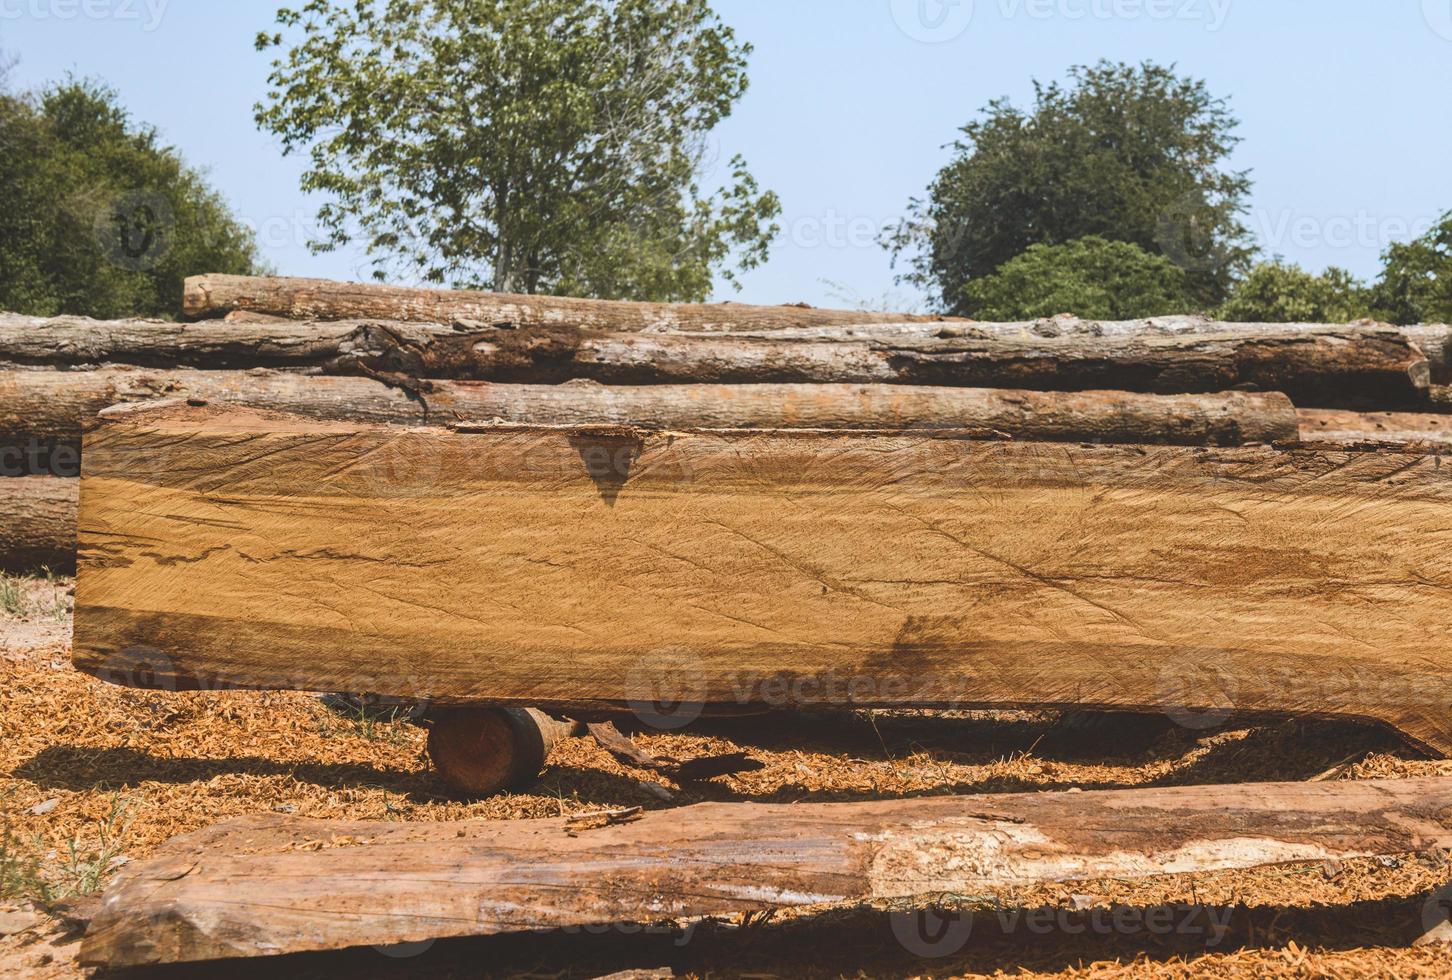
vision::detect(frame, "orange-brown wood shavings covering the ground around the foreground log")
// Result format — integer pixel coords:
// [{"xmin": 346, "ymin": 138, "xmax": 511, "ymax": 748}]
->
[{"xmin": 0, "ymin": 579, "xmax": 1452, "ymax": 980}]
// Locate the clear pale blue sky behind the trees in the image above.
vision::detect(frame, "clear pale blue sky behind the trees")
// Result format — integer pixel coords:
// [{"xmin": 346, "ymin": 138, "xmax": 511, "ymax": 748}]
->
[{"xmin": 0, "ymin": 0, "xmax": 1452, "ymax": 305}]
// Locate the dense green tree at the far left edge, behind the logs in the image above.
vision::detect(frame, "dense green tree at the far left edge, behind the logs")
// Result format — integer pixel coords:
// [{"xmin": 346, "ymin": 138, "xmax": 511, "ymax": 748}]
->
[{"xmin": 0, "ymin": 80, "xmax": 257, "ymax": 318}]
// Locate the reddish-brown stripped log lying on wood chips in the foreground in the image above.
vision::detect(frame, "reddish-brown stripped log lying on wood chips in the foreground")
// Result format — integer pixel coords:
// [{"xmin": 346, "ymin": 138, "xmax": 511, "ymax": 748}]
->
[{"xmin": 81, "ymin": 778, "xmax": 1452, "ymax": 968}]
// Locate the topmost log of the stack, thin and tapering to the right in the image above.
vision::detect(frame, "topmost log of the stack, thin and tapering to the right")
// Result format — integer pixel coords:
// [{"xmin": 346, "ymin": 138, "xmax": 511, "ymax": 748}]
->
[{"xmin": 182, "ymin": 274, "xmax": 944, "ymax": 331}]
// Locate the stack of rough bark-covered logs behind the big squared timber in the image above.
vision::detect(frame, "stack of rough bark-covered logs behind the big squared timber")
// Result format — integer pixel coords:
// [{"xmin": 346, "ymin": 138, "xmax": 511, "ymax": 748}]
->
[{"xmin": 0, "ymin": 276, "xmax": 1452, "ymax": 583}]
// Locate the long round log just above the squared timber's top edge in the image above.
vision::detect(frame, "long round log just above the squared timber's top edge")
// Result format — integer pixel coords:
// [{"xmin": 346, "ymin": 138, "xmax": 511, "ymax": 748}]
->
[{"xmin": 0, "ymin": 367, "xmax": 1298, "ymax": 452}]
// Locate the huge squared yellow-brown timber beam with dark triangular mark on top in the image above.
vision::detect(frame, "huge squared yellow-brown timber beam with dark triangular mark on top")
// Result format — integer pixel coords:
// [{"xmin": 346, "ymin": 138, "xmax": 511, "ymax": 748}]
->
[{"xmin": 74, "ymin": 408, "xmax": 1452, "ymax": 754}]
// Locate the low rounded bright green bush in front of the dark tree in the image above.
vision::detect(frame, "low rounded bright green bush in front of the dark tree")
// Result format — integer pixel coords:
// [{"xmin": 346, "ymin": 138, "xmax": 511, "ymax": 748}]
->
[{"xmin": 958, "ymin": 235, "xmax": 1196, "ymax": 321}]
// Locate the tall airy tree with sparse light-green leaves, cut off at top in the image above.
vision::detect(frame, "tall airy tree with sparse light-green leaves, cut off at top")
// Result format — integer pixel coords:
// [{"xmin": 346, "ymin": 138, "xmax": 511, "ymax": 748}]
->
[{"xmin": 257, "ymin": 0, "xmax": 780, "ymax": 301}]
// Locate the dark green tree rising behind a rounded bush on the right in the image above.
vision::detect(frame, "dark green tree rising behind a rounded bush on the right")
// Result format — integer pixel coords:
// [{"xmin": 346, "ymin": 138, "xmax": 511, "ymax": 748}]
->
[{"xmin": 884, "ymin": 61, "xmax": 1252, "ymax": 314}]
